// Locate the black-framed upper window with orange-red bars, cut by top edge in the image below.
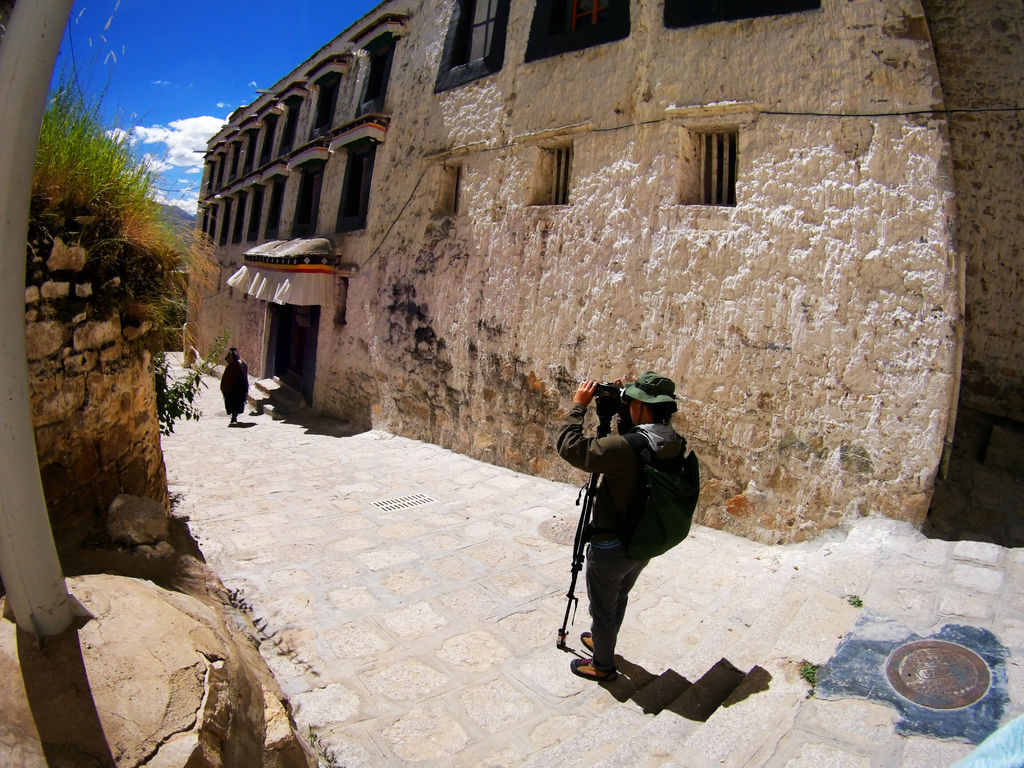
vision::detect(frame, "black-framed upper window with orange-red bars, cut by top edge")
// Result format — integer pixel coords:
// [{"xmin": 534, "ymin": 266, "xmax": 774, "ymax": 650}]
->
[{"xmin": 526, "ymin": 0, "xmax": 630, "ymax": 61}]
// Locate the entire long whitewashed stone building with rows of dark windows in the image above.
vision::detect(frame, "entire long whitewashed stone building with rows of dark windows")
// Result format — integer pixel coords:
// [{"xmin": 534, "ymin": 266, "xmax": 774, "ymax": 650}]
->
[{"xmin": 188, "ymin": 0, "xmax": 1024, "ymax": 541}]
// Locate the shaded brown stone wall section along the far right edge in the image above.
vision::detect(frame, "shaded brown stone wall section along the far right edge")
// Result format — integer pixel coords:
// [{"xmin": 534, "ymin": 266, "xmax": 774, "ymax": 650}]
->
[{"xmin": 924, "ymin": 0, "xmax": 1024, "ymax": 421}]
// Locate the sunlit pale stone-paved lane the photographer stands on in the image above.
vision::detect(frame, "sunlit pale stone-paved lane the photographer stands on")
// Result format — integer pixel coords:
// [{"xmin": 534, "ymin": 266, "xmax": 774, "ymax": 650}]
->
[{"xmin": 164, "ymin": 370, "xmax": 1024, "ymax": 768}]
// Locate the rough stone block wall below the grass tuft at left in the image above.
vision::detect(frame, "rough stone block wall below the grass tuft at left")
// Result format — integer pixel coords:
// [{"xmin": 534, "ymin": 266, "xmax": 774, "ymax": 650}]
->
[{"xmin": 25, "ymin": 236, "xmax": 168, "ymax": 540}]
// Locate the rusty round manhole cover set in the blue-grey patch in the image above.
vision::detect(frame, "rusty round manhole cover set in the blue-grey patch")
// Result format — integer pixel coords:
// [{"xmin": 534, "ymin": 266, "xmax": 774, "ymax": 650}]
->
[{"xmin": 886, "ymin": 640, "xmax": 992, "ymax": 710}]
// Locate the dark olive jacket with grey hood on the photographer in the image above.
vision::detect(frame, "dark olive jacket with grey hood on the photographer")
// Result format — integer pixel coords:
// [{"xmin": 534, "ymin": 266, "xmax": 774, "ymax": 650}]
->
[{"xmin": 557, "ymin": 403, "xmax": 685, "ymax": 542}]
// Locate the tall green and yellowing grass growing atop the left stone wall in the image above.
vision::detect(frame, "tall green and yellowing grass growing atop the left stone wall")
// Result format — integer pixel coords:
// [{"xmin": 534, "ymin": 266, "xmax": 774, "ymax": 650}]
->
[{"xmin": 27, "ymin": 81, "xmax": 189, "ymax": 348}]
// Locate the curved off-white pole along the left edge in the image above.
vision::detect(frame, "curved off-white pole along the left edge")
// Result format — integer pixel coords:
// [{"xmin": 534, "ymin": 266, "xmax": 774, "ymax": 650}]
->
[{"xmin": 0, "ymin": 0, "xmax": 74, "ymax": 636}]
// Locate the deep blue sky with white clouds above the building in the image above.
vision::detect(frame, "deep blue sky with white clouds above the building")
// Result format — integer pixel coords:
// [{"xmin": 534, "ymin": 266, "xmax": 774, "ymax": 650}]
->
[{"xmin": 54, "ymin": 0, "xmax": 378, "ymax": 213}]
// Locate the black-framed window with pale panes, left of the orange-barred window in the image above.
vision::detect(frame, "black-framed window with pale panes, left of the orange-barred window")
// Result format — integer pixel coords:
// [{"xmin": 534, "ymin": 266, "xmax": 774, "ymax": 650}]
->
[{"xmin": 434, "ymin": 0, "xmax": 510, "ymax": 93}]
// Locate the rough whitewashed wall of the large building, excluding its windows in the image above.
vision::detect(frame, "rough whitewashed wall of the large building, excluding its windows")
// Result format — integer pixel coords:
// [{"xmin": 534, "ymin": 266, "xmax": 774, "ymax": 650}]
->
[{"xmin": 192, "ymin": 0, "xmax": 961, "ymax": 541}]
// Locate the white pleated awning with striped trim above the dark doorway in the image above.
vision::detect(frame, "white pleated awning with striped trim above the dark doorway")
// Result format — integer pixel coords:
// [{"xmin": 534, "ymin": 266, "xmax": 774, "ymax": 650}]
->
[{"xmin": 227, "ymin": 238, "xmax": 337, "ymax": 306}]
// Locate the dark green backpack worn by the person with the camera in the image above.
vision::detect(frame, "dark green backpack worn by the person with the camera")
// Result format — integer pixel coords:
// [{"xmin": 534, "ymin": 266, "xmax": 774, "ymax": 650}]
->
[{"xmin": 626, "ymin": 434, "xmax": 700, "ymax": 560}]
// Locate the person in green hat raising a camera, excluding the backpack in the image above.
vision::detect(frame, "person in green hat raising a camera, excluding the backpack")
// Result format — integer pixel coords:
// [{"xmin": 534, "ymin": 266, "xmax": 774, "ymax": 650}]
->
[{"xmin": 557, "ymin": 371, "xmax": 686, "ymax": 682}]
